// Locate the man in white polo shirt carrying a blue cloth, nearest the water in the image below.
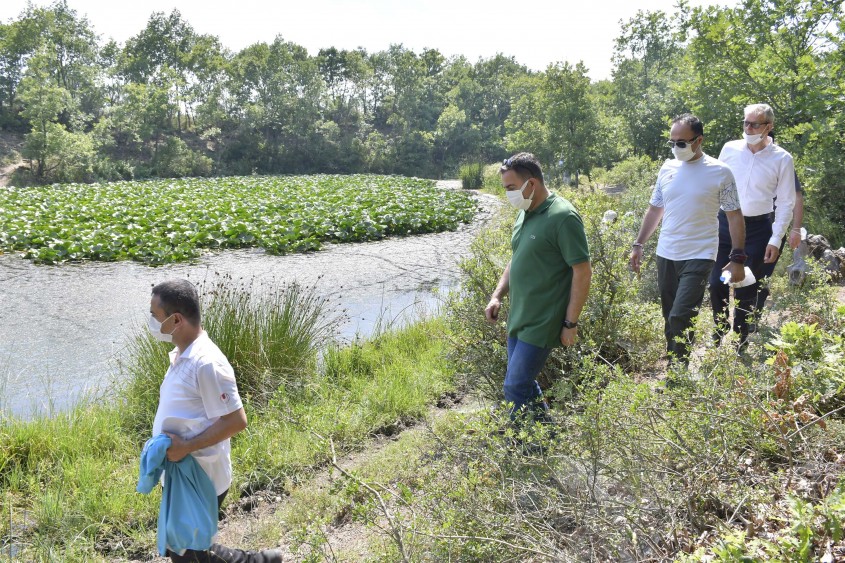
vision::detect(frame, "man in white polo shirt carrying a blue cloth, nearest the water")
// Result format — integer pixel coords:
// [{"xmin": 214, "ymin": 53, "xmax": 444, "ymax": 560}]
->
[{"xmin": 148, "ymin": 279, "xmax": 282, "ymax": 563}]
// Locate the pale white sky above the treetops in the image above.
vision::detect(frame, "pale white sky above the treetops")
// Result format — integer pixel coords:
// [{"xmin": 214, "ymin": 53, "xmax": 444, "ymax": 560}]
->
[{"xmin": 0, "ymin": 0, "xmax": 738, "ymax": 80}]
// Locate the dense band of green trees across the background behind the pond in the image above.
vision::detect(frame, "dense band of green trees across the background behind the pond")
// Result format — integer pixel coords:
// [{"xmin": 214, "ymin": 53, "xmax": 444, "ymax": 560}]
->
[{"xmin": 0, "ymin": 0, "xmax": 845, "ymax": 240}]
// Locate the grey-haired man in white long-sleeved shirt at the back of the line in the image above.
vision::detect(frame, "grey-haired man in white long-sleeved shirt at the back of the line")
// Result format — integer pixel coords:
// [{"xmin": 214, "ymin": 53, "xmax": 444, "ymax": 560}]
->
[{"xmin": 710, "ymin": 104, "xmax": 795, "ymax": 346}]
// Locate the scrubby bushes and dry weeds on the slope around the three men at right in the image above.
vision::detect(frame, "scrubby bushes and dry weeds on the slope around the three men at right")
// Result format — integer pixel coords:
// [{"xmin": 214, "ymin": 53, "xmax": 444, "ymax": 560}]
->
[{"xmin": 265, "ymin": 162, "xmax": 845, "ymax": 562}]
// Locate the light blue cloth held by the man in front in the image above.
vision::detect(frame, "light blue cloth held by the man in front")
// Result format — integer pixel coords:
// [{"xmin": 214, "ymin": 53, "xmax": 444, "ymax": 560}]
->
[{"xmin": 136, "ymin": 434, "xmax": 217, "ymax": 555}]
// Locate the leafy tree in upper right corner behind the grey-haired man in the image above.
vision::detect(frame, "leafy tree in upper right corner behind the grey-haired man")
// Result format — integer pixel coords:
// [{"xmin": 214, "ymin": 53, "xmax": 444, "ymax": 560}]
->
[{"xmin": 685, "ymin": 0, "xmax": 845, "ymax": 240}]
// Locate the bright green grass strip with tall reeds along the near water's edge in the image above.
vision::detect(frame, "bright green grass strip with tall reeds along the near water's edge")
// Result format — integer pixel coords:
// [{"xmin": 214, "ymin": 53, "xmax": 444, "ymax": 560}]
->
[{"xmin": 0, "ymin": 279, "xmax": 453, "ymax": 562}]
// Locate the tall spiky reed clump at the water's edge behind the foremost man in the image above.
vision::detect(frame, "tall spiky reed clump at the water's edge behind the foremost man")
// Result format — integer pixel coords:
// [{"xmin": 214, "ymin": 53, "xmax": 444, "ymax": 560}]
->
[{"xmin": 121, "ymin": 275, "xmax": 342, "ymax": 435}]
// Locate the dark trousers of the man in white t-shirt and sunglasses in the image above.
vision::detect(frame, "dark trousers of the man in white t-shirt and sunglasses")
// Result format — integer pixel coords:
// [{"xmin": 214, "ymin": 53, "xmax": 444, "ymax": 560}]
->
[{"xmin": 657, "ymin": 256, "xmax": 713, "ymax": 363}]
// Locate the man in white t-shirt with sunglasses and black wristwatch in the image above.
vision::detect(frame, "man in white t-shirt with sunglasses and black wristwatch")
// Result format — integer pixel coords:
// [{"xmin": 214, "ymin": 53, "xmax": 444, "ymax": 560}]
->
[{"xmin": 630, "ymin": 114, "xmax": 745, "ymax": 365}]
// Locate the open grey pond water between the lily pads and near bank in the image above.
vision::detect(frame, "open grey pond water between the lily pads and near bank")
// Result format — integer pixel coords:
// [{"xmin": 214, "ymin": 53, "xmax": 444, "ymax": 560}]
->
[{"xmin": 0, "ymin": 188, "xmax": 498, "ymax": 418}]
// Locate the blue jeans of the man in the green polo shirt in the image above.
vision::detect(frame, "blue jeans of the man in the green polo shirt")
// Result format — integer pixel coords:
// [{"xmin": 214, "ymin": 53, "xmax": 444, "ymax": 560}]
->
[{"xmin": 503, "ymin": 336, "xmax": 552, "ymax": 412}]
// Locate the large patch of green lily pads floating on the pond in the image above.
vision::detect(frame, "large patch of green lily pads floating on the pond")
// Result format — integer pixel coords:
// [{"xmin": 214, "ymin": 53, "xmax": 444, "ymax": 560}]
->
[{"xmin": 0, "ymin": 175, "xmax": 475, "ymax": 265}]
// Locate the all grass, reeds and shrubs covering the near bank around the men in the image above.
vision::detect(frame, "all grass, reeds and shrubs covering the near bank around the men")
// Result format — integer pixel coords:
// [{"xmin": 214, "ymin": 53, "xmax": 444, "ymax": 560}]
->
[{"xmin": 0, "ymin": 156, "xmax": 845, "ymax": 561}]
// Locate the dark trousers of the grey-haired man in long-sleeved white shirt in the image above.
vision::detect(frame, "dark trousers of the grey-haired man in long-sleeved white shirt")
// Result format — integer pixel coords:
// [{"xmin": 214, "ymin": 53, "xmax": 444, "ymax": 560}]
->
[{"xmin": 710, "ymin": 211, "xmax": 772, "ymax": 340}]
